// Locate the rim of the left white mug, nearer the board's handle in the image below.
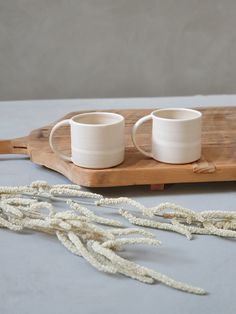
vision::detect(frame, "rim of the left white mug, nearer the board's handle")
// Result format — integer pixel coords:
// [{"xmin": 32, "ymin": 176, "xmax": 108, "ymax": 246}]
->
[{"xmin": 70, "ymin": 111, "xmax": 125, "ymax": 127}]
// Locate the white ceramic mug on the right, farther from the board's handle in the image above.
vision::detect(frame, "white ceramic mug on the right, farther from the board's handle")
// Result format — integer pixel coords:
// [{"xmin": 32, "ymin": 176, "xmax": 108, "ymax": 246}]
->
[{"xmin": 132, "ymin": 108, "xmax": 202, "ymax": 164}]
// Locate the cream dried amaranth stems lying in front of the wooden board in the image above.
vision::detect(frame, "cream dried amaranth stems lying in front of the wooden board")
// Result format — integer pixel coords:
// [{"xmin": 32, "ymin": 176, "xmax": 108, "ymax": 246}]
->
[{"xmin": 0, "ymin": 181, "xmax": 233, "ymax": 294}]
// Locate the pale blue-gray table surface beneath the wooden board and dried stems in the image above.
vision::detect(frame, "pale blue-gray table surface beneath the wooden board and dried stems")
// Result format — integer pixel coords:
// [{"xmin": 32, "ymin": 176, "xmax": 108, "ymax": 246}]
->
[{"xmin": 0, "ymin": 96, "xmax": 236, "ymax": 314}]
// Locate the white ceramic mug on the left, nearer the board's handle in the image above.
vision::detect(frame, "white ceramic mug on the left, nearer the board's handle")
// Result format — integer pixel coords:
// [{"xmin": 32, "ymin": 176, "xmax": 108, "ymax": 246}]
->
[{"xmin": 49, "ymin": 112, "xmax": 125, "ymax": 169}]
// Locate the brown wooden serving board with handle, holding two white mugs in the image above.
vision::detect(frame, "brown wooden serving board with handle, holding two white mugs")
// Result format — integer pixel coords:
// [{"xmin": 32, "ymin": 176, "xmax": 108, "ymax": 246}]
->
[{"xmin": 0, "ymin": 107, "xmax": 236, "ymax": 188}]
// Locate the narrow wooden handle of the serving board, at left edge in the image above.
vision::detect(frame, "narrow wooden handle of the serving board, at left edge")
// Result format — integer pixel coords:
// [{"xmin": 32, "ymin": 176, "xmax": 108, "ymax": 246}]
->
[{"xmin": 0, "ymin": 136, "xmax": 28, "ymax": 155}]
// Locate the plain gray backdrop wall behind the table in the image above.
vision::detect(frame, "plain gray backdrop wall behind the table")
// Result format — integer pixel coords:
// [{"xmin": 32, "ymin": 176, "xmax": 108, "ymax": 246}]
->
[{"xmin": 0, "ymin": 0, "xmax": 236, "ymax": 100}]
